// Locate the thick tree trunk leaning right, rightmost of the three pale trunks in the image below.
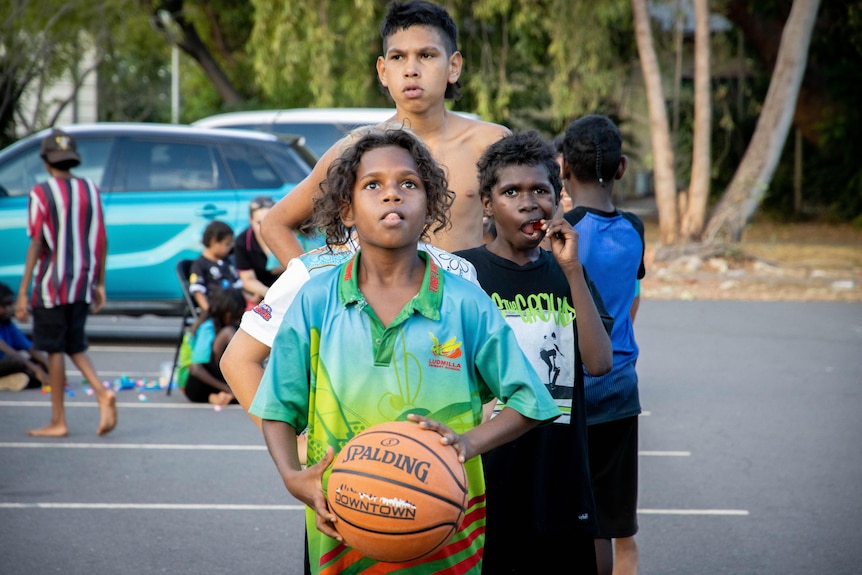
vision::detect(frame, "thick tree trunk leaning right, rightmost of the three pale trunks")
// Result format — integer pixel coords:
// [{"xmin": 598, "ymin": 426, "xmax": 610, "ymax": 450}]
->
[{"xmin": 708, "ymin": 0, "xmax": 820, "ymax": 243}]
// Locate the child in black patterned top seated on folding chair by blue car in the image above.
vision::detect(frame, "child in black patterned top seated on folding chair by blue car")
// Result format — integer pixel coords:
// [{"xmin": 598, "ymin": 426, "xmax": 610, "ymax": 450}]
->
[{"xmin": 189, "ymin": 220, "xmax": 242, "ymax": 311}]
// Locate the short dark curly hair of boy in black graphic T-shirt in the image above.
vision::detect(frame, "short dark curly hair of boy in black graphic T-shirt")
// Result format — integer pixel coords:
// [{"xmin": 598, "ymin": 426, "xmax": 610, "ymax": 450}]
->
[{"xmin": 477, "ymin": 130, "xmax": 563, "ymax": 201}]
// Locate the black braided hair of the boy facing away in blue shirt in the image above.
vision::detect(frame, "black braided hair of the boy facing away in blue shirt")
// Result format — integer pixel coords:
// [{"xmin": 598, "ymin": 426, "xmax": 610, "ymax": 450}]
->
[{"xmin": 562, "ymin": 114, "xmax": 623, "ymax": 185}]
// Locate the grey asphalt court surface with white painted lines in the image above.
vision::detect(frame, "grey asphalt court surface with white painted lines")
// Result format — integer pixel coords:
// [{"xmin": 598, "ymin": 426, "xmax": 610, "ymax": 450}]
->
[{"xmin": 0, "ymin": 301, "xmax": 862, "ymax": 575}]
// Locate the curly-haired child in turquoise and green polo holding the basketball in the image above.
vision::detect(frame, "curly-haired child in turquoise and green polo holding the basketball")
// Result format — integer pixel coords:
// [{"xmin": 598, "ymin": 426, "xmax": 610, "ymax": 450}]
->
[{"xmin": 250, "ymin": 130, "xmax": 560, "ymax": 574}]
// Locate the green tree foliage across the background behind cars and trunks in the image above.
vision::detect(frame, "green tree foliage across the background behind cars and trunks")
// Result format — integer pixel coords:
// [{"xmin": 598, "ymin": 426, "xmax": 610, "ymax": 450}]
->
[{"xmin": 8, "ymin": 0, "xmax": 862, "ymax": 220}]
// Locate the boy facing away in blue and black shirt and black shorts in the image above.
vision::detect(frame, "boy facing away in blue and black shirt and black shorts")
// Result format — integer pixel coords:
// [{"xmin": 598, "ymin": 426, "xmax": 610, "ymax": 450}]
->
[{"xmin": 562, "ymin": 115, "xmax": 644, "ymax": 575}]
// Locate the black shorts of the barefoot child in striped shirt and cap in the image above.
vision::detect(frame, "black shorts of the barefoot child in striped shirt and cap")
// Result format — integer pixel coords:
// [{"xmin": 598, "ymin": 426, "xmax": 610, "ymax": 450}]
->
[{"xmin": 33, "ymin": 302, "xmax": 90, "ymax": 355}]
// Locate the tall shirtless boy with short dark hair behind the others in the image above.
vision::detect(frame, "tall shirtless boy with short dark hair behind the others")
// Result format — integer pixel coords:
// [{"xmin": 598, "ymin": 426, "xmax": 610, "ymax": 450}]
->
[{"xmin": 261, "ymin": 0, "xmax": 509, "ymax": 264}]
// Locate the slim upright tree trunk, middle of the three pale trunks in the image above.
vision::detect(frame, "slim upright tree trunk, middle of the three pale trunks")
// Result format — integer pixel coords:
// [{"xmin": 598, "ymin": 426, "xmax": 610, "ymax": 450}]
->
[{"xmin": 680, "ymin": 0, "xmax": 712, "ymax": 243}]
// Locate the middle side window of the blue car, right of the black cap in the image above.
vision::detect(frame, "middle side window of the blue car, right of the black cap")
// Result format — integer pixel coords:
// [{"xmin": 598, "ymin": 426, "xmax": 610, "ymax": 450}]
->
[{"xmin": 113, "ymin": 139, "xmax": 231, "ymax": 192}]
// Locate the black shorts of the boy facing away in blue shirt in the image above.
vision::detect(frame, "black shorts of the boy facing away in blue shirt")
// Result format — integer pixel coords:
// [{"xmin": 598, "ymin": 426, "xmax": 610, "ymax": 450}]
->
[{"xmin": 588, "ymin": 415, "xmax": 638, "ymax": 539}]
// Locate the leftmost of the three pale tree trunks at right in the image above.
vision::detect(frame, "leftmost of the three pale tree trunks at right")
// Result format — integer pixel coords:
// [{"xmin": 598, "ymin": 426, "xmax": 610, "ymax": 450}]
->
[{"xmin": 631, "ymin": 0, "xmax": 678, "ymax": 246}]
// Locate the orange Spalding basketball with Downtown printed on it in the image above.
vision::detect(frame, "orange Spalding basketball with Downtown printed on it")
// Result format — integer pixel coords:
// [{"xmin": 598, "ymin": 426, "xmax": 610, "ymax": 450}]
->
[{"xmin": 326, "ymin": 421, "xmax": 467, "ymax": 563}]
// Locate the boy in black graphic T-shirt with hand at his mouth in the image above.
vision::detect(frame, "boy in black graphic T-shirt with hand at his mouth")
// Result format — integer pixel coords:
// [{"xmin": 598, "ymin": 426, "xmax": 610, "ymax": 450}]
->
[{"xmin": 456, "ymin": 131, "xmax": 612, "ymax": 575}]
